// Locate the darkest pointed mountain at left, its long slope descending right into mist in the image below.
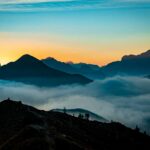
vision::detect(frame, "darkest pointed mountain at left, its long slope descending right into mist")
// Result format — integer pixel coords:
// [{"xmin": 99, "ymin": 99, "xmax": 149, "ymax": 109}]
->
[{"xmin": 0, "ymin": 55, "xmax": 92, "ymax": 86}]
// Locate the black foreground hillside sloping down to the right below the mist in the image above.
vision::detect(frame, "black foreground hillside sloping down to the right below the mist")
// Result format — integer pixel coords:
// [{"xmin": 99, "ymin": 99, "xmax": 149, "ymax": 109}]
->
[{"xmin": 0, "ymin": 100, "xmax": 150, "ymax": 150}]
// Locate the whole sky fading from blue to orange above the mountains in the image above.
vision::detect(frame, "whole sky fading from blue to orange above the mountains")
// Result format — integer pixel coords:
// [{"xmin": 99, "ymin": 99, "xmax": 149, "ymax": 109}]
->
[{"xmin": 0, "ymin": 0, "xmax": 150, "ymax": 66}]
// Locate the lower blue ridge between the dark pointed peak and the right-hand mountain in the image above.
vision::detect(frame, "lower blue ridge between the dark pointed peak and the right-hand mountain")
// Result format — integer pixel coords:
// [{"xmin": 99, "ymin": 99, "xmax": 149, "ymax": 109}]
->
[{"xmin": 42, "ymin": 57, "xmax": 105, "ymax": 80}]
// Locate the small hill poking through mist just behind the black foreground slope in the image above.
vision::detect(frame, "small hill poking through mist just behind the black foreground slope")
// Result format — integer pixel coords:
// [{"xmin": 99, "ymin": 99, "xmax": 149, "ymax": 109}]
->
[{"xmin": 52, "ymin": 108, "xmax": 108, "ymax": 122}]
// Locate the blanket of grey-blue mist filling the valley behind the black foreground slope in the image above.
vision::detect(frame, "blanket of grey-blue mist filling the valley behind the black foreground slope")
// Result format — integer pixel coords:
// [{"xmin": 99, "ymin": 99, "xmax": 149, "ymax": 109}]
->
[{"xmin": 0, "ymin": 76, "xmax": 150, "ymax": 132}]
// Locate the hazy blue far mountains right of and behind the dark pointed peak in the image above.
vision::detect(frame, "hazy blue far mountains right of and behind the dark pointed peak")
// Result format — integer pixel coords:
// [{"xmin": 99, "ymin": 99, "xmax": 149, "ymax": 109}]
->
[{"xmin": 42, "ymin": 50, "xmax": 150, "ymax": 80}]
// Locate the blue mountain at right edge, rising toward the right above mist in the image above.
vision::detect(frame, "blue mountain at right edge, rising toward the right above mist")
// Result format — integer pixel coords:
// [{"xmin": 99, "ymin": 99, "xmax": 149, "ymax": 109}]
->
[{"xmin": 102, "ymin": 50, "xmax": 150, "ymax": 76}]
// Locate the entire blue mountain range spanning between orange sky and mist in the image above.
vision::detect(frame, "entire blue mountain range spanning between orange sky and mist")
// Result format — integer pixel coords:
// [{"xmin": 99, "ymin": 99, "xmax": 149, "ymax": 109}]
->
[{"xmin": 0, "ymin": 50, "xmax": 150, "ymax": 86}]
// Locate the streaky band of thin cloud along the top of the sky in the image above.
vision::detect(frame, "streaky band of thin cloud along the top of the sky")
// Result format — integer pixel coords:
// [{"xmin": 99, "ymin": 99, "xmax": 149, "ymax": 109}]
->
[{"xmin": 0, "ymin": 0, "xmax": 150, "ymax": 11}]
